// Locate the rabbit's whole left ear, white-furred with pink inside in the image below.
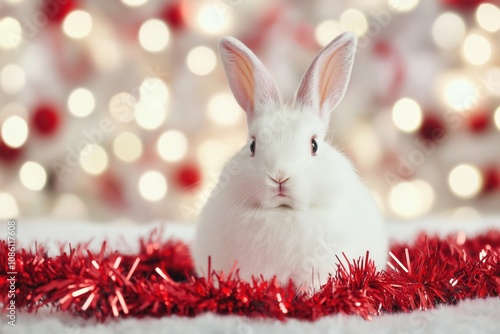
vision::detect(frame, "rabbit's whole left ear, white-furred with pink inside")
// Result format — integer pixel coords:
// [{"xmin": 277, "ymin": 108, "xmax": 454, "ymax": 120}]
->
[{"xmin": 219, "ymin": 36, "xmax": 281, "ymax": 122}]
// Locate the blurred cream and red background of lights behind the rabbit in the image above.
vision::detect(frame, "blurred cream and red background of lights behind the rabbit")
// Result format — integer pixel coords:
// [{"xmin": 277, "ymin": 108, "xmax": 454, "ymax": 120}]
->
[{"xmin": 0, "ymin": 0, "xmax": 500, "ymax": 222}]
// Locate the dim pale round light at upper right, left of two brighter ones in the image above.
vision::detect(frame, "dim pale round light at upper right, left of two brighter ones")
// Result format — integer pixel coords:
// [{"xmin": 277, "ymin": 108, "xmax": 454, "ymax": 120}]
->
[{"xmin": 432, "ymin": 12, "xmax": 465, "ymax": 50}]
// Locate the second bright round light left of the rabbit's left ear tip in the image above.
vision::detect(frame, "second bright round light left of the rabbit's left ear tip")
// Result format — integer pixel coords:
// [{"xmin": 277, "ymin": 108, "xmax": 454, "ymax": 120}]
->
[{"xmin": 139, "ymin": 19, "xmax": 170, "ymax": 52}]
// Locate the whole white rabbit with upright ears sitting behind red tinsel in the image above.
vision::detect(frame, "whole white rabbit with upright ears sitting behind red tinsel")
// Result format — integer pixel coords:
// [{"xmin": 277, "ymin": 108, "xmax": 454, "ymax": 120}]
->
[{"xmin": 193, "ymin": 32, "xmax": 388, "ymax": 290}]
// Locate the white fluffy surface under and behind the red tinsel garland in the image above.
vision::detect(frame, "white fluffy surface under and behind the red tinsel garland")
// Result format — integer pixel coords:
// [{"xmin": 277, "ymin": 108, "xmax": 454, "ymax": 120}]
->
[{"xmin": 0, "ymin": 217, "xmax": 500, "ymax": 334}]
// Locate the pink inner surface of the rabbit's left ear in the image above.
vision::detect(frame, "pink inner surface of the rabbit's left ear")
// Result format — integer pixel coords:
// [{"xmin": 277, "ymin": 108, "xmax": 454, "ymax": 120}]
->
[{"xmin": 226, "ymin": 45, "xmax": 255, "ymax": 112}]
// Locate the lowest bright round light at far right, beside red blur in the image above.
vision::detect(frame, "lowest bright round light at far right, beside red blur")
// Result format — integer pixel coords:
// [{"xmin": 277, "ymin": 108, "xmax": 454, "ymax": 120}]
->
[{"xmin": 448, "ymin": 164, "xmax": 483, "ymax": 198}]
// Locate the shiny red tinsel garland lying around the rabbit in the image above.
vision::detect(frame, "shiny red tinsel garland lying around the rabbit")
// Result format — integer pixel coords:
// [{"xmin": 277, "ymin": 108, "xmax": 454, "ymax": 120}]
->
[{"xmin": 0, "ymin": 231, "xmax": 500, "ymax": 321}]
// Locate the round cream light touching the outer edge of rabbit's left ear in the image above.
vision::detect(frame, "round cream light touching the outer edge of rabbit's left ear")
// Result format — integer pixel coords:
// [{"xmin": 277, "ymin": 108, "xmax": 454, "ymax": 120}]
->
[{"xmin": 207, "ymin": 92, "xmax": 243, "ymax": 126}]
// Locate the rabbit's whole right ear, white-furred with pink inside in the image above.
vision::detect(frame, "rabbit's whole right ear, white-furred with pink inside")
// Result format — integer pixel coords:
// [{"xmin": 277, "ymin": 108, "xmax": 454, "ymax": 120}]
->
[{"xmin": 294, "ymin": 32, "xmax": 357, "ymax": 120}]
